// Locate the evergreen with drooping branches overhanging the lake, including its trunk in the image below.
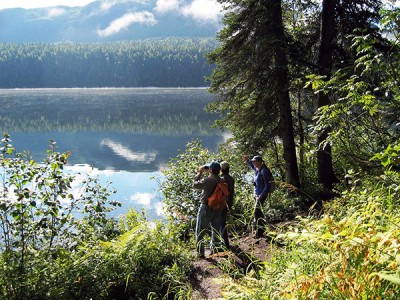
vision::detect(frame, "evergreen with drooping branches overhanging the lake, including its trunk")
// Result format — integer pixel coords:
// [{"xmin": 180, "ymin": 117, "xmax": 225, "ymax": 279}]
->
[{"xmin": 209, "ymin": 0, "xmax": 300, "ymax": 186}]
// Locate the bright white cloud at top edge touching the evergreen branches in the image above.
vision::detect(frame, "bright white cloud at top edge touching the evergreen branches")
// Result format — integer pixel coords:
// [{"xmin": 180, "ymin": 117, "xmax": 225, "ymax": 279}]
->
[{"xmin": 182, "ymin": 0, "xmax": 222, "ymax": 22}]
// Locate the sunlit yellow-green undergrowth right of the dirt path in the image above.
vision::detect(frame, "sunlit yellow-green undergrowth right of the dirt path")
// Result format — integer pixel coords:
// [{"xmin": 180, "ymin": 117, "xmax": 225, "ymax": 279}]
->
[{"xmin": 280, "ymin": 173, "xmax": 400, "ymax": 299}]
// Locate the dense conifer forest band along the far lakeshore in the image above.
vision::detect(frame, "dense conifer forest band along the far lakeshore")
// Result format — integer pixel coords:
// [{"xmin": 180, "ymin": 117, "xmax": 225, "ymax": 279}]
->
[{"xmin": 0, "ymin": 38, "xmax": 217, "ymax": 88}]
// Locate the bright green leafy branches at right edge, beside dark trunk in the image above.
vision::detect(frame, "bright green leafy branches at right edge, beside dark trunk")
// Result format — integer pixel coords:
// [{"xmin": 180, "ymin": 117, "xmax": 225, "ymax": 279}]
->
[{"xmin": 309, "ymin": 7, "xmax": 400, "ymax": 173}]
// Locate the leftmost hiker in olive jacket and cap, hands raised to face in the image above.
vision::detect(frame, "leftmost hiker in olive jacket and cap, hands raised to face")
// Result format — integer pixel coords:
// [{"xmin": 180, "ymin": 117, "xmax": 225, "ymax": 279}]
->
[{"xmin": 193, "ymin": 161, "xmax": 222, "ymax": 258}]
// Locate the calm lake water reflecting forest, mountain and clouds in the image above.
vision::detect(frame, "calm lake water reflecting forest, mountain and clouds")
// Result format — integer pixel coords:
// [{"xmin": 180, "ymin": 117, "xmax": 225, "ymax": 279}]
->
[{"xmin": 0, "ymin": 88, "xmax": 224, "ymax": 219}]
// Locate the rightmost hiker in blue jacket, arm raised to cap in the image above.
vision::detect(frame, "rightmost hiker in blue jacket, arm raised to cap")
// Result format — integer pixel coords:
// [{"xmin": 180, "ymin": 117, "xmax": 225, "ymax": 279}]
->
[{"xmin": 244, "ymin": 155, "xmax": 273, "ymax": 238}]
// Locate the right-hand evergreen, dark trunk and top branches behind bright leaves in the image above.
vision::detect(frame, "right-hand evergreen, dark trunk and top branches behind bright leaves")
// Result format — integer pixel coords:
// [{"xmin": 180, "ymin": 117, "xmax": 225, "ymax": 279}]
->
[{"xmin": 317, "ymin": 0, "xmax": 381, "ymax": 189}]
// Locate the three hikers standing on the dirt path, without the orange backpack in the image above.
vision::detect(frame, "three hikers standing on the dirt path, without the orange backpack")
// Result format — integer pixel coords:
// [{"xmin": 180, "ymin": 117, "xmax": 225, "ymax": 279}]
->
[{"xmin": 193, "ymin": 155, "xmax": 271, "ymax": 258}]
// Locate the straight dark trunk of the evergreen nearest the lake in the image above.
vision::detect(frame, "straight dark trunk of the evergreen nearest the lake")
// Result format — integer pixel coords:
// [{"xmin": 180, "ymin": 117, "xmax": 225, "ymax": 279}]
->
[{"xmin": 266, "ymin": 0, "xmax": 300, "ymax": 187}]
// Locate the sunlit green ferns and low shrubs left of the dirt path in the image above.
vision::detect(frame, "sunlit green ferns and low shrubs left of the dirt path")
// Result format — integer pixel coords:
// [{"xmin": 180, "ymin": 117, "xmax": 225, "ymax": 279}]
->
[{"xmin": 66, "ymin": 211, "xmax": 191, "ymax": 299}]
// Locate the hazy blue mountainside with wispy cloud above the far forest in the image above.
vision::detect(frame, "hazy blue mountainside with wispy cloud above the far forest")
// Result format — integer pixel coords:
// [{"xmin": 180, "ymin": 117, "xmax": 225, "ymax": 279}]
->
[{"xmin": 0, "ymin": 0, "xmax": 220, "ymax": 43}]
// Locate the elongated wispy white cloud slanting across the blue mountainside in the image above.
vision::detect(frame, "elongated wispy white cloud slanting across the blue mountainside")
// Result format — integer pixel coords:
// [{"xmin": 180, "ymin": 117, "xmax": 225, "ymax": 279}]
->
[{"xmin": 97, "ymin": 11, "xmax": 157, "ymax": 36}]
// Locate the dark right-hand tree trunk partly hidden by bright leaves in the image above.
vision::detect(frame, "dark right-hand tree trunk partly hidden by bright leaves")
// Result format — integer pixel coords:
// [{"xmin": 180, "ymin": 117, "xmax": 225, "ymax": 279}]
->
[{"xmin": 317, "ymin": 0, "xmax": 338, "ymax": 189}]
